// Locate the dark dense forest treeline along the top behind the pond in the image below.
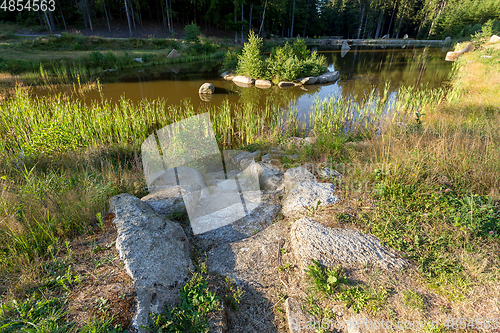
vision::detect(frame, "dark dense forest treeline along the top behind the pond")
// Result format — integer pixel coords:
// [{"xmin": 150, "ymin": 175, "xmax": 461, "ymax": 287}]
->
[{"xmin": 0, "ymin": 0, "xmax": 500, "ymax": 42}]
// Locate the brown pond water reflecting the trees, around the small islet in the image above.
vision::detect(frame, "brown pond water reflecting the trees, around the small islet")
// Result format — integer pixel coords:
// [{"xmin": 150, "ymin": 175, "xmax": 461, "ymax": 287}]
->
[{"xmin": 35, "ymin": 46, "xmax": 452, "ymax": 117}]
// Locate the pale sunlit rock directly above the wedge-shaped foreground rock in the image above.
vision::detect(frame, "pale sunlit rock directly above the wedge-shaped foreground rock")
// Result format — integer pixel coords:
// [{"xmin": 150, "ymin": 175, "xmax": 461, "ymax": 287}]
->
[{"xmin": 282, "ymin": 182, "xmax": 340, "ymax": 217}]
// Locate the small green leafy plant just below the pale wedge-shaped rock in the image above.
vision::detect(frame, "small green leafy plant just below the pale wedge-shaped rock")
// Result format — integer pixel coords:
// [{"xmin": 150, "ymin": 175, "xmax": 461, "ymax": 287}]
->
[{"xmin": 306, "ymin": 259, "xmax": 347, "ymax": 295}]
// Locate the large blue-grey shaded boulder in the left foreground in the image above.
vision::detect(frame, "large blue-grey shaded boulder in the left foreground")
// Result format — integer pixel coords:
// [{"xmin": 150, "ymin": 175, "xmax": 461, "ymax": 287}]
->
[{"xmin": 110, "ymin": 193, "xmax": 194, "ymax": 331}]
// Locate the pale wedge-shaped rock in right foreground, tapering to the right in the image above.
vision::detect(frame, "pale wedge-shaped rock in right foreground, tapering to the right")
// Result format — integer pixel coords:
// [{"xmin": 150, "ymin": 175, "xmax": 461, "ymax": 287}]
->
[{"xmin": 290, "ymin": 218, "xmax": 408, "ymax": 270}]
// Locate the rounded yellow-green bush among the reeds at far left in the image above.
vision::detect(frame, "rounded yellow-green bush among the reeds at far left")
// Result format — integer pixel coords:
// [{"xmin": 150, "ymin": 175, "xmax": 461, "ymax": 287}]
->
[{"xmin": 24, "ymin": 122, "xmax": 82, "ymax": 155}]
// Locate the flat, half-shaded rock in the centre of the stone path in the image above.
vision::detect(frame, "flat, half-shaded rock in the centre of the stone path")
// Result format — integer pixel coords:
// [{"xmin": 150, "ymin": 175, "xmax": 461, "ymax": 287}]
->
[{"xmin": 196, "ymin": 191, "xmax": 281, "ymax": 250}]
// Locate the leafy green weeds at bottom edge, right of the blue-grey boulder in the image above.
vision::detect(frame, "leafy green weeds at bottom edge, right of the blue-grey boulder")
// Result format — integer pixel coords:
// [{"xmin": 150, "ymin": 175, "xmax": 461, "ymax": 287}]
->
[{"xmin": 150, "ymin": 272, "xmax": 220, "ymax": 333}]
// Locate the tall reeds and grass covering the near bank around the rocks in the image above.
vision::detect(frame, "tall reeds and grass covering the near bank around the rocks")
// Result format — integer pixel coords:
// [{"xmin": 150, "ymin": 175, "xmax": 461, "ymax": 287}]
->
[{"xmin": 0, "ymin": 37, "xmax": 500, "ymax": 332}]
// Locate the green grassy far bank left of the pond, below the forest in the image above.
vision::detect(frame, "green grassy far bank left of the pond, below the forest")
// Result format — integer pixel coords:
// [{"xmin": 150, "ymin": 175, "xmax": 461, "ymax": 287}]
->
[{"xmin": 0, "ymin": 33, "xmax": 227, "ymax": 84}]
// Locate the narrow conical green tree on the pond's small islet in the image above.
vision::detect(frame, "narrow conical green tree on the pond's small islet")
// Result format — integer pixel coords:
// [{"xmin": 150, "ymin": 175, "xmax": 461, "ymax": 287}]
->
[{"xmin": 236, "ymin": 30, "xmax": 263, "ymax": 79}]
